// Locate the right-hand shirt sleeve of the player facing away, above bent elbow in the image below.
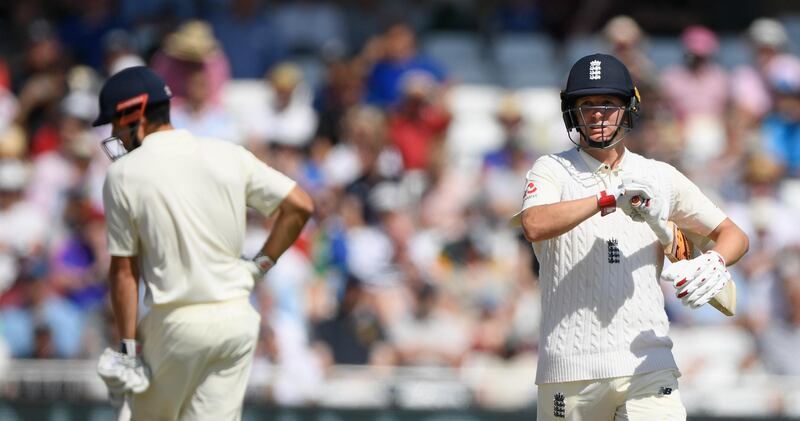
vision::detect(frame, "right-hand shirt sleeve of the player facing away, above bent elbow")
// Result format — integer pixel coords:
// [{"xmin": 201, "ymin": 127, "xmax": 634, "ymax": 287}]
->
[{"xmin": 241, "ymin": 148, "xmax": 297, "ymax": 216}]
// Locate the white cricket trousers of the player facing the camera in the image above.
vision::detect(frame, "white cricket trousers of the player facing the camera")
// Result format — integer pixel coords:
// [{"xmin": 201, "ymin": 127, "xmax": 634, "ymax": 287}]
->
[{"xmin": 536, "ymin": 369, "xmax": 686, "ymax": 421}]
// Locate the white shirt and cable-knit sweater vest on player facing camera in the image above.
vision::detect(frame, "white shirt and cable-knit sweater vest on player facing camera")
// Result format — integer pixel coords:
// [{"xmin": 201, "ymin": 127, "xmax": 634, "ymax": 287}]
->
[{"xmin": 523, "ymin": 148, "xmax": 726, "ymax": 384}]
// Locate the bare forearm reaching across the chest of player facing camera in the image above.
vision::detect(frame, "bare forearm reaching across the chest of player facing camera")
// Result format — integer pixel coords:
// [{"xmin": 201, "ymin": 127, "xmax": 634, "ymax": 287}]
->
[{"xmin": 522, "ymin": 196, "xmax": 600, "ymax": 242}]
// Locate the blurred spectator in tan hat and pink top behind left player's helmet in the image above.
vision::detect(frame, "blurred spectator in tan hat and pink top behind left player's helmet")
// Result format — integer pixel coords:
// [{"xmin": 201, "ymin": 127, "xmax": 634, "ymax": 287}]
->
[{"xmin": 152, "ymin": 20, "xmax": 231, "ymax": 104}]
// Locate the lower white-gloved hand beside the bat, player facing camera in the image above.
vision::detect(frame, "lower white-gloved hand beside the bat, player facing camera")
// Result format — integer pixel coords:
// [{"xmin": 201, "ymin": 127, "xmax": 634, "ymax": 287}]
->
[{"xmin": 661, "ymin": 251, "xmax": 731, "ymax": 308}]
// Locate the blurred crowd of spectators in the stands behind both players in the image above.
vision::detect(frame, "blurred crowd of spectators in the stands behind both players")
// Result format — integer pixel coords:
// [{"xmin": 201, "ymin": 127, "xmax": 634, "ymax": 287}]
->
[{"xmin": 0, "ymin": 0, "xmax": 800, "ymax": 403}]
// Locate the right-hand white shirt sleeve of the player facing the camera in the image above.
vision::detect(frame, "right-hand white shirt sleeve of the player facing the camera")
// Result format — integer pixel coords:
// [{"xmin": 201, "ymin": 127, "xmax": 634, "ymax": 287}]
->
[{"xmin": 669, "ymin": 166, "xmax": 727, "ymax": 237}]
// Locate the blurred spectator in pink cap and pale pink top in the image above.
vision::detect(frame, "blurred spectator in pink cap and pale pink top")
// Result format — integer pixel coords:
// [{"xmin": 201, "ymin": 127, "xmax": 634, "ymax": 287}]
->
[{"xmin": 661, "ymin": 26, "xmax": 728, "ymax": 164}]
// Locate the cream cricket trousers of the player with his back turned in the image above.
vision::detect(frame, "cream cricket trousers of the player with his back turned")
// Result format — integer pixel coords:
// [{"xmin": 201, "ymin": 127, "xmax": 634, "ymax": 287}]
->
[{"xmin": 131, "ymin": 297, "xmax": 261, "ymax": 421}]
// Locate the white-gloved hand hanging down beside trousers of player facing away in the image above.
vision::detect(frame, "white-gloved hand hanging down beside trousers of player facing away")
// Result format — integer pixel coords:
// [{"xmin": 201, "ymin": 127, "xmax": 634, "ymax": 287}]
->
[{"xmin": 97, "ymin": 348, "xmax": 150, "ymax": 407}]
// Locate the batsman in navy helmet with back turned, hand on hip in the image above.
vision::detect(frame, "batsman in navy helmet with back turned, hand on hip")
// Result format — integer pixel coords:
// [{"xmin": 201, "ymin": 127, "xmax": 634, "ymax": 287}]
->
[{"xmin": 94, "ymin": 67, "xmax": 313, "ymax": 420}]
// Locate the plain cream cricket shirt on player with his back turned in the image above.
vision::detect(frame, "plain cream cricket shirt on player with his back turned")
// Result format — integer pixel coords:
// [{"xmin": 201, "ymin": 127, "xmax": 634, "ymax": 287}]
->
[{"xmin": 103, "ymin": 130, "xmax": 295, "ymax": 305}]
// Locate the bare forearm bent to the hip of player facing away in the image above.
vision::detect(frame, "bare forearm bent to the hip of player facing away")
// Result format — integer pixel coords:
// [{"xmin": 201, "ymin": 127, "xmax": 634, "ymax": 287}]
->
[{"xmin": 261, "ymin": 187, "xmax": 314, "ymax": 260}]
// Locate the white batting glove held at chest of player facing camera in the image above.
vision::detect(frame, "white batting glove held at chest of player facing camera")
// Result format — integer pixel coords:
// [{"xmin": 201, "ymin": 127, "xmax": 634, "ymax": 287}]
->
[{"xmin": 620, "ymin": 175, "xmax": 675, "ymax": 246}]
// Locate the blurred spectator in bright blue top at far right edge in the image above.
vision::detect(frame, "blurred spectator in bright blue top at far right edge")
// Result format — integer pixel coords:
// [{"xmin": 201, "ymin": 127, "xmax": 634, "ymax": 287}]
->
[{"xmin": 762, "ymin": 56, "xmax": 800, "ymax": 177}]
